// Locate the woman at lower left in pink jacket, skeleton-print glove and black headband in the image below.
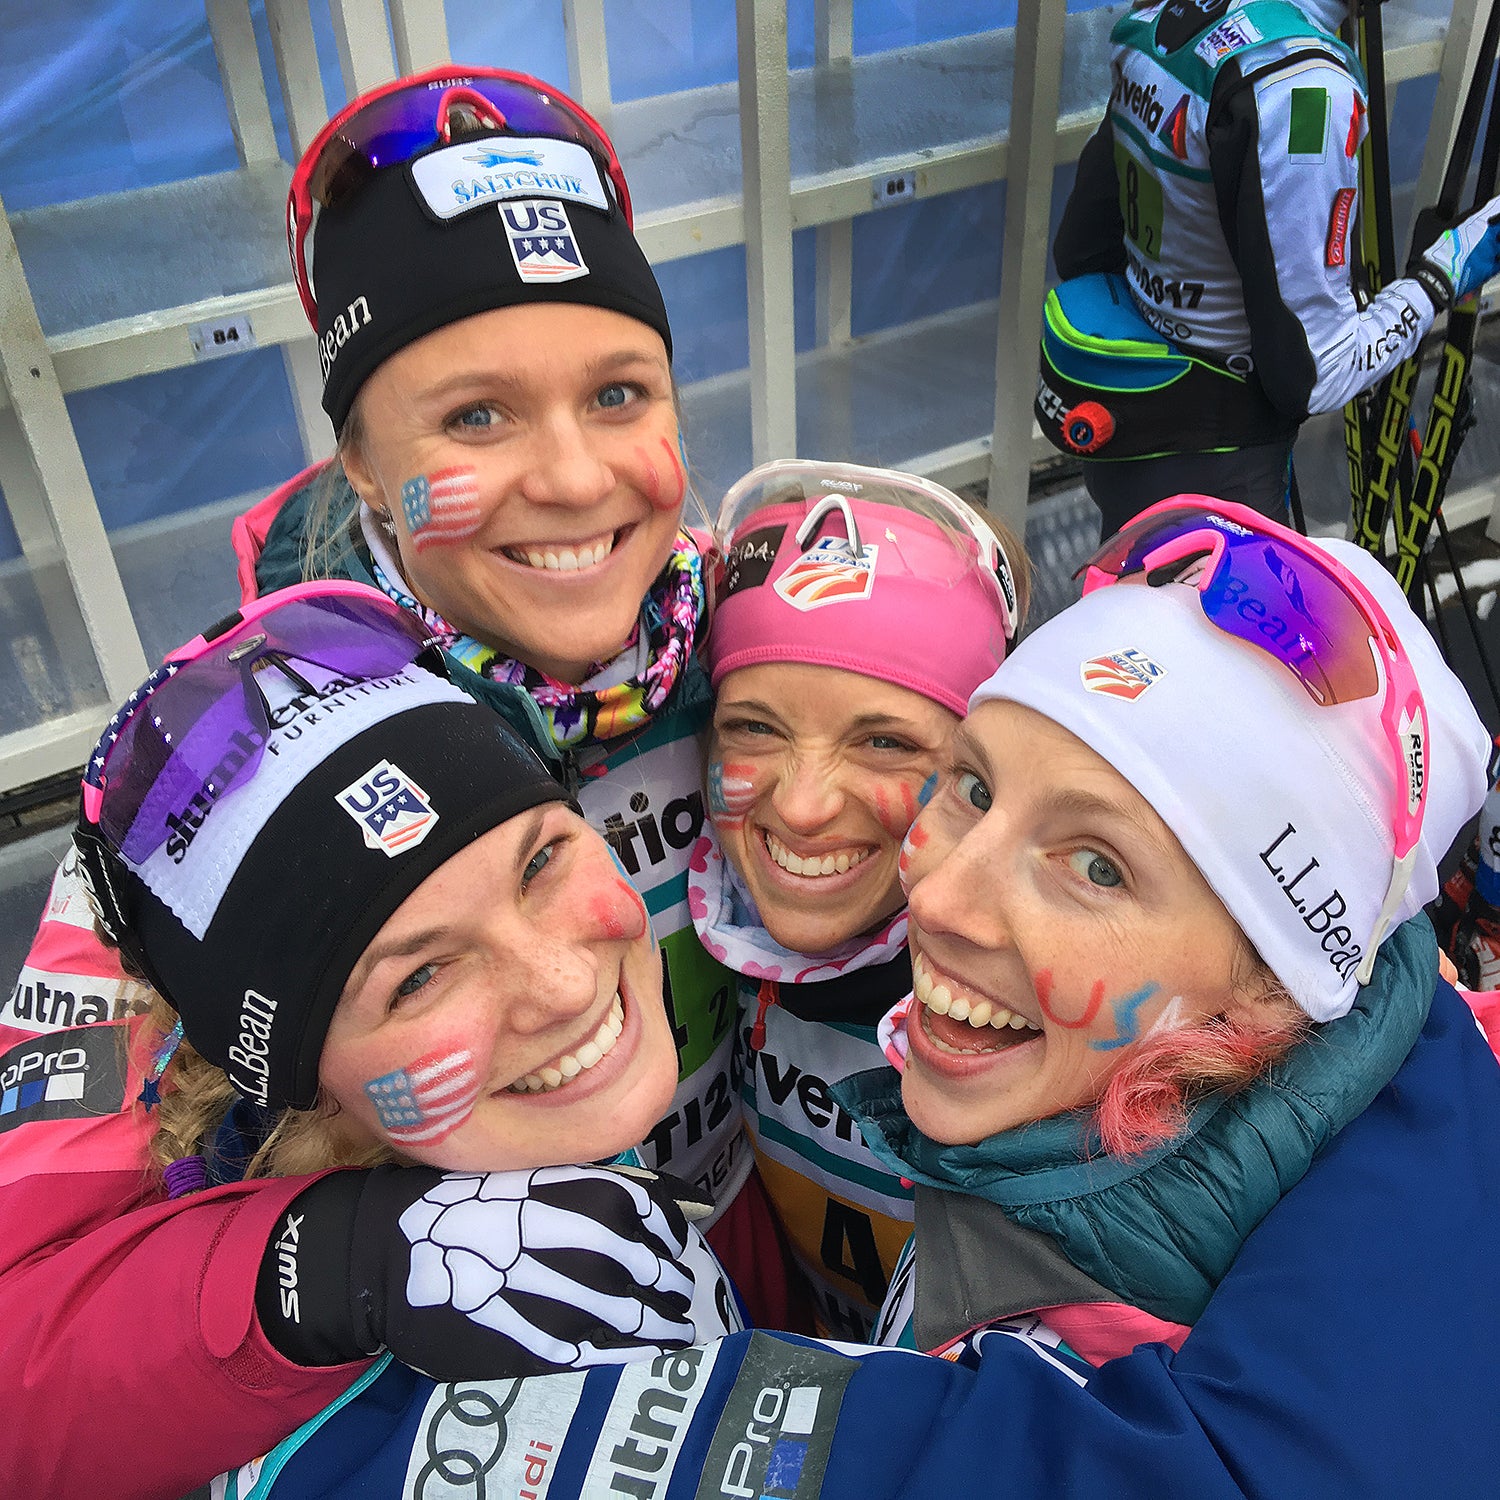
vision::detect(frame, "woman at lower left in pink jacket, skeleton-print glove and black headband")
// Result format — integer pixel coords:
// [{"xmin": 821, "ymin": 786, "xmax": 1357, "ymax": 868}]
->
[{"xmin": 0, "ymin": 582, "xmax": 740, "ymax": 1496}]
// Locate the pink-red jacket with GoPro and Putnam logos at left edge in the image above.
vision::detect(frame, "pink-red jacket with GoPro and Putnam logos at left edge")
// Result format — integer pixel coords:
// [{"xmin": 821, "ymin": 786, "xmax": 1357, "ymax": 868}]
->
[{"xmin": 0, "ymin": 861, "xmax": 365, "ymax": 1500}]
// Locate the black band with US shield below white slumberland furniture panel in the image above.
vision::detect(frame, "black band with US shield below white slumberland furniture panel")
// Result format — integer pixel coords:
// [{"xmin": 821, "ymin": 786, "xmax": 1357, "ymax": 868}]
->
[{"xmin": 111, "ymin": 702, "xmax": 566, "ymax": 1110}]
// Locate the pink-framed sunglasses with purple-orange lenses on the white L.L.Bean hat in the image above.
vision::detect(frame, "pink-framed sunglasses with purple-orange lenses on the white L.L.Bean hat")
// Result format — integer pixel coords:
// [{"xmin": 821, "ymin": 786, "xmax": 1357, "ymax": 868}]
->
[{"xmin": 1074, "ymin": 495, "xmax": 1430, "ymax": 984}]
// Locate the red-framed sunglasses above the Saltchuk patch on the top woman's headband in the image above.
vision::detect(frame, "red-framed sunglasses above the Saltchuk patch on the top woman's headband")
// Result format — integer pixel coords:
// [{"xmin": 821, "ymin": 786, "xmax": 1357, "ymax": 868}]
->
[{"xmin": 287, "ymin": 63, "xmax": 635, "ymax": 327}]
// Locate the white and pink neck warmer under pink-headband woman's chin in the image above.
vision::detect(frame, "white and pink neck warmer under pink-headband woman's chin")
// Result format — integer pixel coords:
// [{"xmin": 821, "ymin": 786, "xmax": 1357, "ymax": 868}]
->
[{"xmin": 687, "ymin": 824, "xmax": 906, "ymax": 984}]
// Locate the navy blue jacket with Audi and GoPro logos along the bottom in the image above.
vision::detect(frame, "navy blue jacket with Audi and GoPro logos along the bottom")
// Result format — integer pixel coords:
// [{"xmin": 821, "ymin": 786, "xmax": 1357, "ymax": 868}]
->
[{"xmin": 217, "ymin": 983, "xmax": 1500, "ymax": 1500}]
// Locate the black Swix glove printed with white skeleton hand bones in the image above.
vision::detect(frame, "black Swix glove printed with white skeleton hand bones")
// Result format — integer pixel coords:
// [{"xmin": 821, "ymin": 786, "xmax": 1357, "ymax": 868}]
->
[{"xmin": 255, "ymin": 1167, "xmax": 695, "ymax": 1380}]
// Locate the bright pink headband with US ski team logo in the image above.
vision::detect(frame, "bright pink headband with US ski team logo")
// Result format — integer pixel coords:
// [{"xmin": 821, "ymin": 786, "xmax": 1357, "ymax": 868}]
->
[{"xmin": 708, "ymin": 495, "xmax": 1008, "ymax": 717}]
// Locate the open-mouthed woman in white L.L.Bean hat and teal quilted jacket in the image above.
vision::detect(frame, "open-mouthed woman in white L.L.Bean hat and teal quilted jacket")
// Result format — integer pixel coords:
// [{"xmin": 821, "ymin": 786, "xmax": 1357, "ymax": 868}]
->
[{"xmin": 837, "ymin": 497, "xmax": 1488, "ymax": 1364}]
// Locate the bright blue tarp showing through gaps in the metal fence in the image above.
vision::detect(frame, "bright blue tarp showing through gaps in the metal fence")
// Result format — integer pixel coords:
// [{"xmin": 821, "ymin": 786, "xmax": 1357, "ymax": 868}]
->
[{"xmin": 0, "ymin": 0, "xmax": 1436, "ymax": 560}]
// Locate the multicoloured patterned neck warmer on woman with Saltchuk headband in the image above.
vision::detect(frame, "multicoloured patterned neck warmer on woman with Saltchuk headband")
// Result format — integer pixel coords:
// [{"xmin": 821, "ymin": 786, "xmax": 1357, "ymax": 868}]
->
[{"xmin": 360, "ymin": 507, "xmax": 704, "ymax": 749}]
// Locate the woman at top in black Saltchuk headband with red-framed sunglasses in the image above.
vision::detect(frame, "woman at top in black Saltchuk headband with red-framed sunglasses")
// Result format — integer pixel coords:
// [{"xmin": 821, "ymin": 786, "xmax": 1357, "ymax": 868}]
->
[{"xmin": 17, "ymin": 65, "xmax": 782, "ymax": 1320}]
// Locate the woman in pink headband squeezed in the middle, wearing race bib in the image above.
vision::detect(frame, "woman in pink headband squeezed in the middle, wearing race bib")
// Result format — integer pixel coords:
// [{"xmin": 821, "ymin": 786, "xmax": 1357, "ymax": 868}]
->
[{"xmin": 689, "ymin": 461, "xmax": 1023, "ymax": 1338}]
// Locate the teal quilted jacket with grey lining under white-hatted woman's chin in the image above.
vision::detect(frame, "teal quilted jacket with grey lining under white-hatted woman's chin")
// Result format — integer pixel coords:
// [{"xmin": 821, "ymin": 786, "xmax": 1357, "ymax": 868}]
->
[{"xmin": 834, "ymin": 915, "xmax": 1437, "ymax": 1353}]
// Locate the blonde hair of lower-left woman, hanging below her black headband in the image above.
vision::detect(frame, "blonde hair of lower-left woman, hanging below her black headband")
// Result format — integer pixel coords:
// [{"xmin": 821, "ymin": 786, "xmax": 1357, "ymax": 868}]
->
[{"xmin": 135, "ymin": 990, "xmax": 402, "ymax": 1179}]
